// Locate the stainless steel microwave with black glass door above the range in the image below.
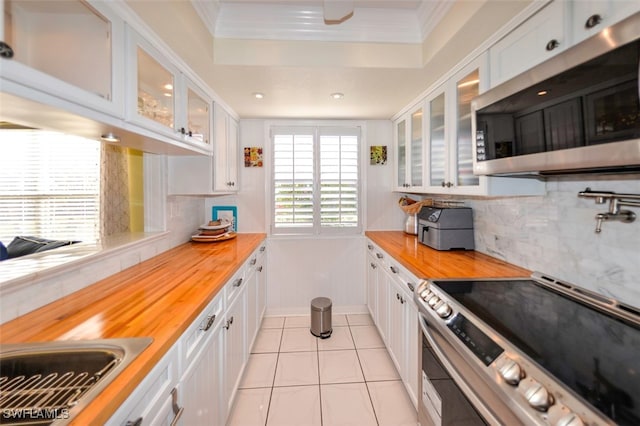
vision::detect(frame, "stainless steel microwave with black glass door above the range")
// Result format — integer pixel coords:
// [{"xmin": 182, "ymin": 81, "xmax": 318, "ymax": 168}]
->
[{"xmin": 471, "ymin": 13, "xmax": 640, "ymax": 176}]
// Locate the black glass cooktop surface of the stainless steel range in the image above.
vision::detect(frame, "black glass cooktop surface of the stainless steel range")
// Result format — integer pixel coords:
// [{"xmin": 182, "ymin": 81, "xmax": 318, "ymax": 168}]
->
[{"xmin": 434, "ymin": 280, "xmax": 640, "ymax": 426}]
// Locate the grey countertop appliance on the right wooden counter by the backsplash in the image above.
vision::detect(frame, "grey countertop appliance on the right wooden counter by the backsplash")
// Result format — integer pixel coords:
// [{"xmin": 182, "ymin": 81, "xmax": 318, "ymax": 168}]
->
[{"xmin": 418, "ymin": 206, "xmax": 475, "ymax": 250}]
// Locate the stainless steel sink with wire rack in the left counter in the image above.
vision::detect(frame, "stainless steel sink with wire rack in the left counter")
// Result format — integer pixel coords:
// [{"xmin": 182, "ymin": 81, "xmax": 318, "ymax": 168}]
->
[{"xmin": 0, "ymin": 337, "xmax": 153, "ymax": 425}]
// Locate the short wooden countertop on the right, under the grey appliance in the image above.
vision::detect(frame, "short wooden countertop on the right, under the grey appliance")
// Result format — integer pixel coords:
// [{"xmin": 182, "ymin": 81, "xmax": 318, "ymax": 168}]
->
[{"xmin": 365, "ymin": 231, "xmax": 531, "ymax": 278}]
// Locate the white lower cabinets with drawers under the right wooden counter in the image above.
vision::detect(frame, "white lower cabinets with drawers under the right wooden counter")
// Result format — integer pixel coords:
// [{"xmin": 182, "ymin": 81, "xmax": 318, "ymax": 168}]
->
[{"xmin": 367, "ymin": 242, "xmax": 420, "ymax": 407}]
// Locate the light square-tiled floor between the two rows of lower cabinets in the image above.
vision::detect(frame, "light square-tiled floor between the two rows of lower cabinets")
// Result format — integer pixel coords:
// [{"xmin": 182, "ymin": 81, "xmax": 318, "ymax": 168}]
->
[{"xmin": 227, "ymin": 314, "xmax": 417, "ymax": 426}]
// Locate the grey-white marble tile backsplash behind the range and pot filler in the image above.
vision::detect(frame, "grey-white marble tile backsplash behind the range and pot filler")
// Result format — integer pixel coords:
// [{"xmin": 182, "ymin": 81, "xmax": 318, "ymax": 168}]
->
[{"xmin": 466, "ymin": 175, "xmax": 640, "ymax": 307}]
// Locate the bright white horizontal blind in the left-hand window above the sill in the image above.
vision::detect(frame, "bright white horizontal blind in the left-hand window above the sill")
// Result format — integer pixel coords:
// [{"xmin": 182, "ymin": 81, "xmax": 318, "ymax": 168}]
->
[{"xmin": 0, "ymin": 130, "xmax": 100, "ymax": 245}]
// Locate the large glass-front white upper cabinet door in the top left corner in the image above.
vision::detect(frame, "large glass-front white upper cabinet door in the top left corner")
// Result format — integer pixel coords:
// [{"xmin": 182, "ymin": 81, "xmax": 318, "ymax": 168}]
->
[{"xmin": 0, "ymin": 0, "xmax": 124, "ymax": 118}]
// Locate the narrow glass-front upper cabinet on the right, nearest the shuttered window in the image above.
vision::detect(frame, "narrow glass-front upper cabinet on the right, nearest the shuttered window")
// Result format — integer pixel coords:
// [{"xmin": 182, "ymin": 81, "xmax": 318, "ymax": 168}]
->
[{"xmin": 394, "ymin": 105, "xmax": 424, "ymax": 191}]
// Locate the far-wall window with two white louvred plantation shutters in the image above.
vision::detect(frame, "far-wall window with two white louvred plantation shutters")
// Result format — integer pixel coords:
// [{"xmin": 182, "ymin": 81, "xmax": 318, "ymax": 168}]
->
[{"xmin": 271, "ymin": 127, "xmax": 361, "ymax": 234}]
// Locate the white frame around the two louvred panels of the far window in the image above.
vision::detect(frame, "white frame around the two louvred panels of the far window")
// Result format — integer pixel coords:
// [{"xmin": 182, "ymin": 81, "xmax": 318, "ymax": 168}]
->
[{"xmin": 264, "ymin": 120, "xmax": 366, "ymax": 237}]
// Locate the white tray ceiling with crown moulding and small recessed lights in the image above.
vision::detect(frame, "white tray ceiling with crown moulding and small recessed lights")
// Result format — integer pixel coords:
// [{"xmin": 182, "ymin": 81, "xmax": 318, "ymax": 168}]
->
[{"xmin": 193, "ymin": 0, "xmax": 453, "ymax": 119}]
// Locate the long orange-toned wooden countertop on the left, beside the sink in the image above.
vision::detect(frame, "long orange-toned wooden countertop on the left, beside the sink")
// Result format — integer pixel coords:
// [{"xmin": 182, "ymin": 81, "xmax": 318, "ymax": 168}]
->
[{"xmin": 0, "ymin": 234, "xmax": 266, "ymax": 425}]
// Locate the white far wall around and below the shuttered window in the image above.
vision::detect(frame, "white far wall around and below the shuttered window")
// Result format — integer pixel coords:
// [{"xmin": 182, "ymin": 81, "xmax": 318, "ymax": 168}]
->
[{"xmin": 214, "ymin": 120, "xmax": 404, "ymax": 314}]
